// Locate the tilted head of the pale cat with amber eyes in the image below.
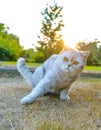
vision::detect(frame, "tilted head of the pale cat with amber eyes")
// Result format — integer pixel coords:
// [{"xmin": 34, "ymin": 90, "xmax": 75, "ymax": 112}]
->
[{"xmin": 58, "ymin": 47, "xmax": 89, "ymax": 75}]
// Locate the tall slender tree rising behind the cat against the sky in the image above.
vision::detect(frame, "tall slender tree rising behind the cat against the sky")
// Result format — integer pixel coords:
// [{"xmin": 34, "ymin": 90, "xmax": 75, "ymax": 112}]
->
[{"xmin": 36, "ymin": 1, "xmax": 64, "ymax": 60}]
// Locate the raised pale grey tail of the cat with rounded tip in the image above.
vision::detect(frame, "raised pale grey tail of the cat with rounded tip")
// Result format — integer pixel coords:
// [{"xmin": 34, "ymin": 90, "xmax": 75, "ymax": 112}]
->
[{"xmin": 17, "ymin": 58, "xmax": 33, "ymax": 86}]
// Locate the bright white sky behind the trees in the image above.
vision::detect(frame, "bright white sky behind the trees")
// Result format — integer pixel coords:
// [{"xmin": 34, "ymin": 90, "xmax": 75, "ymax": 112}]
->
[{"xmin": 0, "ymin": 0, "xmax": 101, "ymax": 49}]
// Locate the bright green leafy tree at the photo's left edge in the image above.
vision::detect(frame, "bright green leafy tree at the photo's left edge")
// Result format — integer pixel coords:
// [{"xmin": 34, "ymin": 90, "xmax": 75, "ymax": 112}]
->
[{"xmin": 0, "ymin": 23, "xmax": 23, "ymax": 61}]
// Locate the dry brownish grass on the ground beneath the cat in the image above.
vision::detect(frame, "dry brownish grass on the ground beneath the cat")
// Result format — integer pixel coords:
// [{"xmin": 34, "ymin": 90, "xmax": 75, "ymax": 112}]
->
[{"xmin": 0, "ymin": 78, "xmax": 101, "ymax": 130}]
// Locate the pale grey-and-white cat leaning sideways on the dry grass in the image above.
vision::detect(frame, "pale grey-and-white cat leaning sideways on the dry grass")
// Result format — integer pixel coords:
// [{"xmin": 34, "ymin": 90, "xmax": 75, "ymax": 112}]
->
[{"xmin": 17, "ymin": 47, "xmax": 89, "ymax": 104}]
